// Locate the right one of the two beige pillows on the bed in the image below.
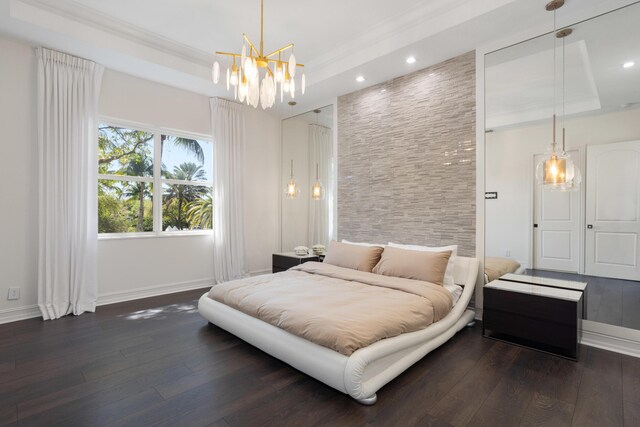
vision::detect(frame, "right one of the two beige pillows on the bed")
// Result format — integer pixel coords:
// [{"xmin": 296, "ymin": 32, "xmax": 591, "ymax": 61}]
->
[{"xmin": 373, "ymin": 246, "xmax": 451, "ymax": 286}]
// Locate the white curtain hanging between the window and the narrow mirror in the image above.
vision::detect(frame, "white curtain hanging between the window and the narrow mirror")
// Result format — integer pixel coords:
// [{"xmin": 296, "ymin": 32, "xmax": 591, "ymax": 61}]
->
[{"xmin": 211, "ymin": 98, "xmax": 248, "ymax": 283}]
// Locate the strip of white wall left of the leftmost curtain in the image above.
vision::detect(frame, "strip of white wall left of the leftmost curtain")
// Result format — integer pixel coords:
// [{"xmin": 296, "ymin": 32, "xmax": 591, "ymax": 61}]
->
[{"xmin": 0, "ymin": 37, "xmax": 38, "ymax": 318}]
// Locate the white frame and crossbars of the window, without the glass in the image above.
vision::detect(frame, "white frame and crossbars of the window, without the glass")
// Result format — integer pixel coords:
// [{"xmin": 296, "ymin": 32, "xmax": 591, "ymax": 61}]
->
[{"xmin": 96, "ymin": 116, "xmax": 215, "ymax": 240}]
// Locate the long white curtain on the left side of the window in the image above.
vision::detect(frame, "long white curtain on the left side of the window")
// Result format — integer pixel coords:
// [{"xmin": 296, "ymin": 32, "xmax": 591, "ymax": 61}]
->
[{"xmin": 36, "ymin": 48, "xmax": 103, "ymax": 320}]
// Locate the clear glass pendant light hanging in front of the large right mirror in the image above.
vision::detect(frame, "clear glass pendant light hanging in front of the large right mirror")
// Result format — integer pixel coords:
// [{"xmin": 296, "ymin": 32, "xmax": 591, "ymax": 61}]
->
[{"xmin": 536, "ymin": 0, "xmax": 577, "ymax": 189}]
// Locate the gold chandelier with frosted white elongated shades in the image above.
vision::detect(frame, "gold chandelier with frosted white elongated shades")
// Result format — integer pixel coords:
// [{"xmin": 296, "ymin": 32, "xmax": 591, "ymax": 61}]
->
[{"xmin": 212, "ymin": 0, "xmax": 306, "ymax": 109}]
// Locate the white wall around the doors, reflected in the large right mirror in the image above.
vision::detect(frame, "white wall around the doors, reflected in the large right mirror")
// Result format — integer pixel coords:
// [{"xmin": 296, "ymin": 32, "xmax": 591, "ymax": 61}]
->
[{"xmin": 485, "ymin": 109, "xmax": 640, "ymax": 265}]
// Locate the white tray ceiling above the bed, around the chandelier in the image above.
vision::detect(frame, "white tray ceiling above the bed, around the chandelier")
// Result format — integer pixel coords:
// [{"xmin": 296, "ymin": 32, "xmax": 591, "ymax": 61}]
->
[{"xmin": 0, "ymin": 0, "xmax": 630, "ymax": 115}]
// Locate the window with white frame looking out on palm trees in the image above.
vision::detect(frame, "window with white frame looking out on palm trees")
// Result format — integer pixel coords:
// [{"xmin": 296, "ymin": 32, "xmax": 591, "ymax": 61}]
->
[{"xmin": 98, "ymin": 124, "xmax": 213, "ymax": 235}]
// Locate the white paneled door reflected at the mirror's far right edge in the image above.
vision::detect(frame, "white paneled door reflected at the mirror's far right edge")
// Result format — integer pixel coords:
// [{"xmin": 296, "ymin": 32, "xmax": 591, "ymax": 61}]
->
[{"xmin": 585, "ymin": 141, "xmax": 640, "ymax": 280}]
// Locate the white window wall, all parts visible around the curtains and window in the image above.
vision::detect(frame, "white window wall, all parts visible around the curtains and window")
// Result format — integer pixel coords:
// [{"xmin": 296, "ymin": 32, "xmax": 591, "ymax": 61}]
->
[{"xmin": 0, "ymin": 37, "xmax": 280, "ymax": 323}]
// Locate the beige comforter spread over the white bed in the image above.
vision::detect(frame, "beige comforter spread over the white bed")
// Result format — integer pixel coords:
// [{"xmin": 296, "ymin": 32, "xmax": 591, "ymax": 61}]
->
[{"xmin": 209, "ymin": 262, "xmax": 452, "ymax": 356}]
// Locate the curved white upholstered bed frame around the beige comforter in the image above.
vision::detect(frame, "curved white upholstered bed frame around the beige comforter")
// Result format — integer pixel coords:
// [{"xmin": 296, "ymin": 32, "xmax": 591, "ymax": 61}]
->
[{"xmin": 198, "ymin": 257, "xmax": 479, "ymax": 405}]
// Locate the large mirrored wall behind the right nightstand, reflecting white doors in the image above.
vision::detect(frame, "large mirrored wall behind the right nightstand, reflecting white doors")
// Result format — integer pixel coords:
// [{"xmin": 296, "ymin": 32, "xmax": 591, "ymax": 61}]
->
[{"xmin": 485, "ymin": 3, "xmax": 640, "ymax": 329}]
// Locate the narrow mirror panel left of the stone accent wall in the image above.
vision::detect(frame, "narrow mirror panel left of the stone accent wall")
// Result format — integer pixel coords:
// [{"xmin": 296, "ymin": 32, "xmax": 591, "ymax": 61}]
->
[{"xmin": 281, "ymin": 105, "xmax": 336, "ymax": 252}]
